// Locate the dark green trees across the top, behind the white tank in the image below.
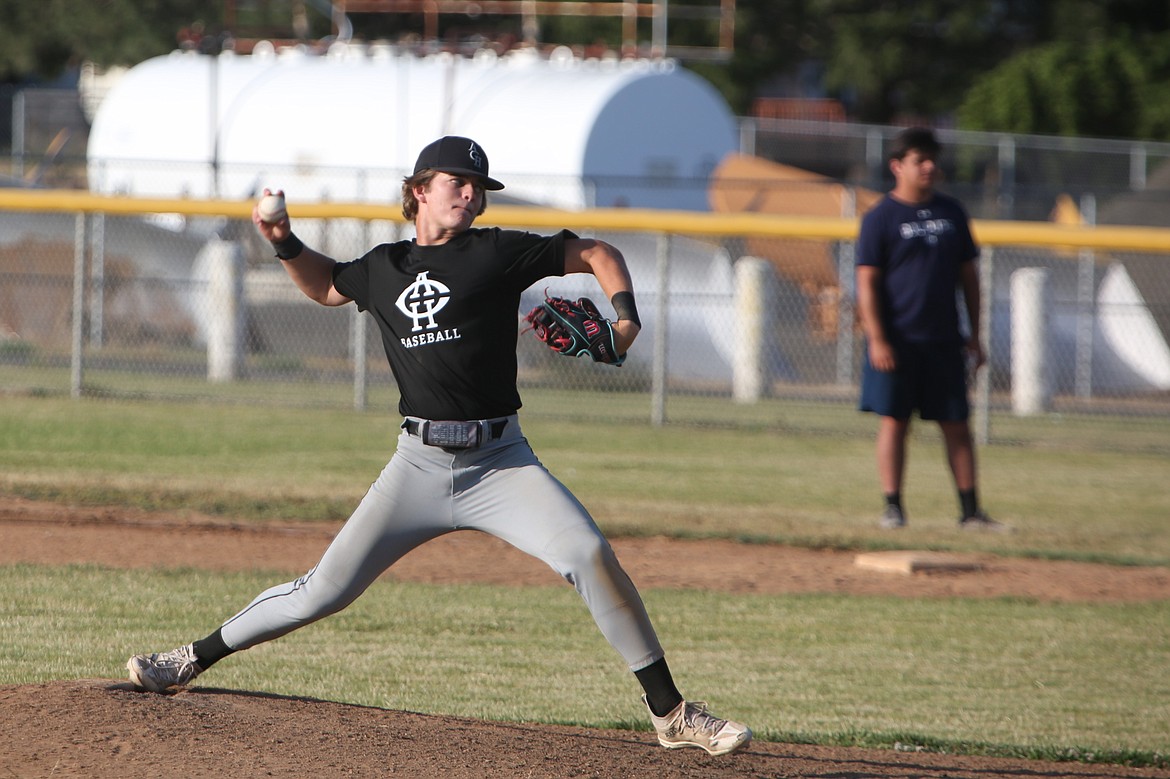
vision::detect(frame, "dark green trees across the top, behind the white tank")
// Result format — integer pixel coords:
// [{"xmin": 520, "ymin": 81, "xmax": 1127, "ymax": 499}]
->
[{"xmin": 13, "ymin": 0, "xmax": 1170, "ymax": 139}]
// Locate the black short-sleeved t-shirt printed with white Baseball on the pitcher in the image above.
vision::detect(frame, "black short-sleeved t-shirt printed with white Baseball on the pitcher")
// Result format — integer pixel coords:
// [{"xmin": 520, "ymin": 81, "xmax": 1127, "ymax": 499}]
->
[{"xmin": 333, "ymin": 228, "xmax": 577, "ymax": 420}]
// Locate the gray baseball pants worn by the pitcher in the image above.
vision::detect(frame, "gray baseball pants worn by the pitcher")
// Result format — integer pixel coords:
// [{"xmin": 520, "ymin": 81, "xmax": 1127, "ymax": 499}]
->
[{"xmin": 221, "ymin": 415, "xmax": 662, "ymax": 670}]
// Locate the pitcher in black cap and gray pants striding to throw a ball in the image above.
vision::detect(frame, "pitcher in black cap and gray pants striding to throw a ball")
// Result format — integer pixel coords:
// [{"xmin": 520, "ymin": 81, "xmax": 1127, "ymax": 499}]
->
[{"xmin": 128, "ymin": 136, "xmax": 751, "ymax": 754}]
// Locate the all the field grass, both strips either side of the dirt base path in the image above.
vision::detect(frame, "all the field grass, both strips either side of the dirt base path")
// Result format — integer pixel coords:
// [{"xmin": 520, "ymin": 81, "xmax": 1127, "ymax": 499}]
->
[{"xmin": 0, "ymin": 397, "xmax": 1170, "ymax": 764}]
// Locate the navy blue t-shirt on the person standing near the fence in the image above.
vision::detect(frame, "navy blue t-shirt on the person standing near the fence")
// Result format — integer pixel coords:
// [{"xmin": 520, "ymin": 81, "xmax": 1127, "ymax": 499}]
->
[{"xmin": 856, "ymin": 193, "xmax": 979, "ymax": 343}]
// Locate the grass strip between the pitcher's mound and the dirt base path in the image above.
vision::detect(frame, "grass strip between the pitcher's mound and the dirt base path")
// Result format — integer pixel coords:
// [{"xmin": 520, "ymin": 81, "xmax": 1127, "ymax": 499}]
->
[{"xmin": 0, "ymin": 565, "xmax": 1170, "ymax": 765}]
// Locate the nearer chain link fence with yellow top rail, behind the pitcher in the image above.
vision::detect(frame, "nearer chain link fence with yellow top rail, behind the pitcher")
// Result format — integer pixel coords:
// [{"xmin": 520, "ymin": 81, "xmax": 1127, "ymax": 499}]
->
[{"xmin": 0, "ymin": 191, "xmax": 1170, "ymax": 453}]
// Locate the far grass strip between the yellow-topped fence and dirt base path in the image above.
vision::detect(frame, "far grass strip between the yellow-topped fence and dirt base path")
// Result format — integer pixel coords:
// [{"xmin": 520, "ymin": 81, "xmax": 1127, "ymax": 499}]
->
[{"xmin": 0, "ymin": 395, "xmax": 1170, "ymax": 565}]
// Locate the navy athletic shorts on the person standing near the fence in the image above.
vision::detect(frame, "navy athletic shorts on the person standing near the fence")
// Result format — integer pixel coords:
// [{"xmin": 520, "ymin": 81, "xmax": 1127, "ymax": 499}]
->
[{"xmin": 859, "ymin": 343, "xmax": 971, "ymax": 422}]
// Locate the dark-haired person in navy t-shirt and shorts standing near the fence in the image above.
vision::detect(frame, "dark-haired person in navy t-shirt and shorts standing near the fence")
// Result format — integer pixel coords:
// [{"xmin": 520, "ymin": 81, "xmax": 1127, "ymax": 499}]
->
[{"xmin": 856, "ymin": 127, "xmax": 1006, "ymax": 531}]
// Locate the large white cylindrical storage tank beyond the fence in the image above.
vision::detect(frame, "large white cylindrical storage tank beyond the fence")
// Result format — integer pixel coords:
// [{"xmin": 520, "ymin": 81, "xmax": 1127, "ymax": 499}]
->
[{"xmin": 88, "ymin": 43, "xmax": 737, "ymax": 211}]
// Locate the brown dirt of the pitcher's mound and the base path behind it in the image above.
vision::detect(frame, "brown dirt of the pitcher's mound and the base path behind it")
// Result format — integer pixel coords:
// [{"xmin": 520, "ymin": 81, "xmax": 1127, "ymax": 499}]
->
[{"xmin": 0, "ymin": 499, "xmax": 1170, "ymax": 779}]
